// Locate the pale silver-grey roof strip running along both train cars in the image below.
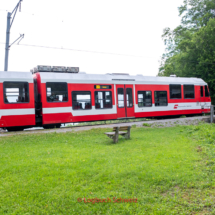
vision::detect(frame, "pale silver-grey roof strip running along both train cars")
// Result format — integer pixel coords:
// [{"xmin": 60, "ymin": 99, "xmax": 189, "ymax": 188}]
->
[{"xmin": 0, "ymin": 72, "xmax": 207, "ymax": 85}]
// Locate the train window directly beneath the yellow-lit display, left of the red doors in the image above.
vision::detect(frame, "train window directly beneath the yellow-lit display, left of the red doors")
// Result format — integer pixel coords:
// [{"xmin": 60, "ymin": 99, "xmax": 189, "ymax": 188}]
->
[{"xmin": 95, "ymin": 91, "xmax": 112, "ymax": 109}]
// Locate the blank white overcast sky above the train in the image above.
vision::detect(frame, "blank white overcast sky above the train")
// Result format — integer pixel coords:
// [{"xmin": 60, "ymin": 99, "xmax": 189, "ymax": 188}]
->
[{"xmin": 0, "ymin": 0, "xmax": 183, "ymax": 76}]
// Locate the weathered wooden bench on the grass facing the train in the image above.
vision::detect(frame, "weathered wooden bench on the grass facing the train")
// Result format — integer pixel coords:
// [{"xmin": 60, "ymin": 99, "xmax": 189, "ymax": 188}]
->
[{"xmin": 105, "ymin": 126, "xmax": 131, "ymax": 143}]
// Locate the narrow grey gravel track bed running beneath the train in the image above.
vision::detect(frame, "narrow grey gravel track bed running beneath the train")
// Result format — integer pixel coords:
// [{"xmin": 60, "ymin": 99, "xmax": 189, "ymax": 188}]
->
[{"xmin": 0, "ymin": 116, "xmax": 209, "ymax": 137}]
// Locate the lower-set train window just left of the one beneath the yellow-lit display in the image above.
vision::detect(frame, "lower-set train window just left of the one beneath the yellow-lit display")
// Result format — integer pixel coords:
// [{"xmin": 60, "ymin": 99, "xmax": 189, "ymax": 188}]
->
[{"xmin": 72, "ymin": 91, "xmax": 92, "ymax": 110}]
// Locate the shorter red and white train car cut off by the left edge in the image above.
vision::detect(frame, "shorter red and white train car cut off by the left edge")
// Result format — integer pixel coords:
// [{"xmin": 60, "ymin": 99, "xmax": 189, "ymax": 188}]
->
[{"xmin": 0, "ymin": 72, "xmax": 36, "ymax": 131}]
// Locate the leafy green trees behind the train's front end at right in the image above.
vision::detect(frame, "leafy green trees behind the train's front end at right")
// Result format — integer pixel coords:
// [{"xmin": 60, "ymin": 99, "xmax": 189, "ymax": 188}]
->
[{"xmin": 158, "ymin": 0, "xmax": 215, "ymax": 104}]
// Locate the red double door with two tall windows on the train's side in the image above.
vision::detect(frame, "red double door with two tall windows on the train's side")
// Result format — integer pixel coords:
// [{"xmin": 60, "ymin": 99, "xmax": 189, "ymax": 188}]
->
[{"xmin": 116, "ymin": 84, "xmax": 134, "ymax": 119}]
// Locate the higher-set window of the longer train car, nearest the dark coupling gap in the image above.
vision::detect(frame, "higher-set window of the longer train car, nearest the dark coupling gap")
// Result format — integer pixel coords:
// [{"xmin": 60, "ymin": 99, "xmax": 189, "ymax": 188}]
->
[{"xmin": 46, "ymin": 82, "xmax": 68, "ymax": 102}]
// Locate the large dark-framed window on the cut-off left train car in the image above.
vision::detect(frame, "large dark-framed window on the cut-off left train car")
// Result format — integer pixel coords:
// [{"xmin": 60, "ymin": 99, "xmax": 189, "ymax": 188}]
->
[{"xmin": 4, "ymin": 82, "xmax": 29, "ymax": 103}]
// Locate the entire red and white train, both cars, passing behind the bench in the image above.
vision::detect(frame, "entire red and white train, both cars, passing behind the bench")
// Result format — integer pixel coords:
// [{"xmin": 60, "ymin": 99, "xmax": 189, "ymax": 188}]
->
[{"xmin": 0, "ymin": 66, "xmax": 211, "ymax": 131}]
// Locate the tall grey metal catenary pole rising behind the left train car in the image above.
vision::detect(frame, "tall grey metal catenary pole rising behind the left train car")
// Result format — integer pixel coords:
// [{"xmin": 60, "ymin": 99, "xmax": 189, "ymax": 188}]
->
[{"xmin": 4, "ymin": 0, "xmax": 22, "ymax": 71}]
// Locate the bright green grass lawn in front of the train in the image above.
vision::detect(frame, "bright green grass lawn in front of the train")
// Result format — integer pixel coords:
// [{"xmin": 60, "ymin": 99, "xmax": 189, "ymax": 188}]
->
[{"xmin": 0, "ymin": 124, "xmax": 215, "ymax": 215}]
